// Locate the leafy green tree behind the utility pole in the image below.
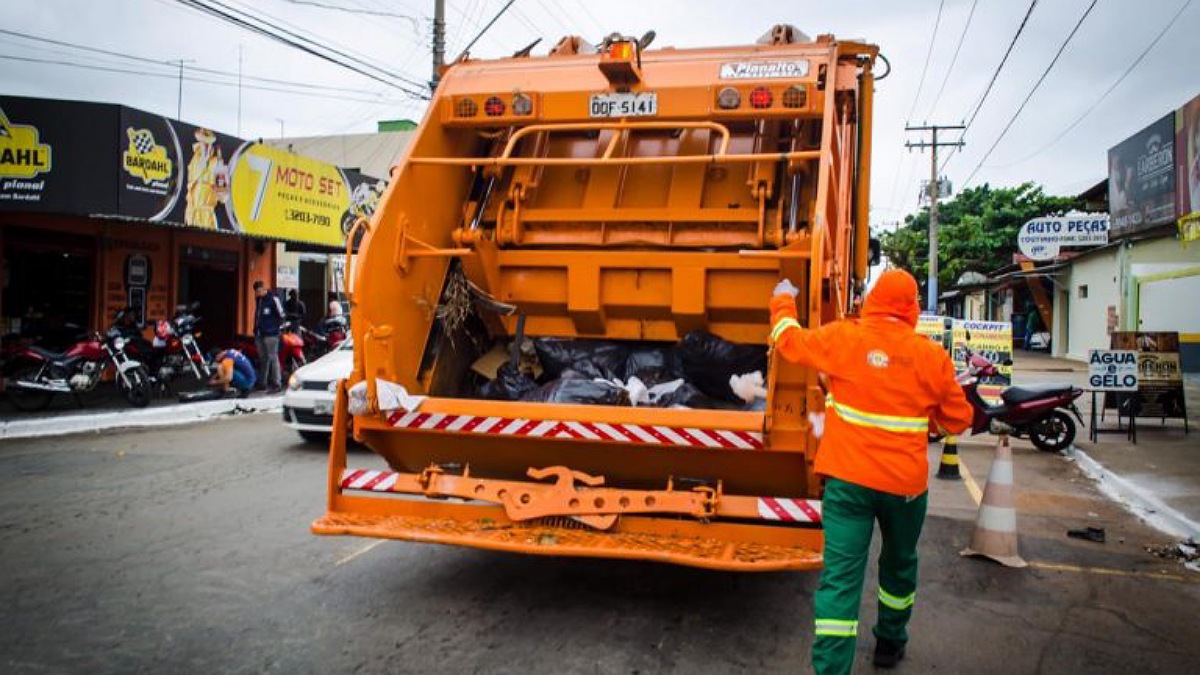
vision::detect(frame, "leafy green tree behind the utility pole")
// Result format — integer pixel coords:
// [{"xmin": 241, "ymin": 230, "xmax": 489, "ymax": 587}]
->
[{"xmin": 880, "ymin": 183, "xmax": 1081, "ymax": 294}]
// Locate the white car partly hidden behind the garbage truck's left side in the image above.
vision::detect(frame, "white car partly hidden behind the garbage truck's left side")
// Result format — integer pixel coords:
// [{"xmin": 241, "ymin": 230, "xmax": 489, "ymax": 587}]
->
[{"xmin": 283, "ymin": 340, "xmax": 354, "ymax": 443}]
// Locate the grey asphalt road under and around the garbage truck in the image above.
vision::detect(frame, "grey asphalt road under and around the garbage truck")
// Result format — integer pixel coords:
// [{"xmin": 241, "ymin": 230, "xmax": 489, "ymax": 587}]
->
[{"xmin": 0, "ymin": 414, "xmax": 1200, "ymax": 674}]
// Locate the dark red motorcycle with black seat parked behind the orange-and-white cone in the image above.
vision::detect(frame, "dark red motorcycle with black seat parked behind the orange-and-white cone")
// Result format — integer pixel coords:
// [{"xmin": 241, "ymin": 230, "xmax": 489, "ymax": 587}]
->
[{"xmin": 960, "ymin": 345, "xmax": 1084, "ymax": 453}]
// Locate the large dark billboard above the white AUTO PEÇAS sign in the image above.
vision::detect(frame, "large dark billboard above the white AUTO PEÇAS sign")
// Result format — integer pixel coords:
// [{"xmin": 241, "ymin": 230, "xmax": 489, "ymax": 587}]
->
[{"xmin": 1109, "ymin": 113, "xmax": 1175, "ymax": 235}]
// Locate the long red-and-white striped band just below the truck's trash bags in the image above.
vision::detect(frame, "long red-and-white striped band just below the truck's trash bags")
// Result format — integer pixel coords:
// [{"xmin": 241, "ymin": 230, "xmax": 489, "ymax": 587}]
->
[{"xmin": 388, "ymin": 411, "xmax": 762, "ymax": 450}]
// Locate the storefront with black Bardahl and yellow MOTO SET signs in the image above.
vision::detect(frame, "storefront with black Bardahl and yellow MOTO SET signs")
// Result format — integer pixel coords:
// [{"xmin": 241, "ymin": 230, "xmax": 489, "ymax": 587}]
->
[{"xmin": 0, "ymin": 97, "xmax": 374, "ymax": 347}]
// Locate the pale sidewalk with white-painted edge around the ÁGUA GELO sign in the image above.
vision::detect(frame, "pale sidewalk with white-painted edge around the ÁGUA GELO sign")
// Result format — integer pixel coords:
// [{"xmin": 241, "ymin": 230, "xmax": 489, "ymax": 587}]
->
[{"xmin": 1013, "ymin": 352, "xmax": 1200, "ymax": 538}]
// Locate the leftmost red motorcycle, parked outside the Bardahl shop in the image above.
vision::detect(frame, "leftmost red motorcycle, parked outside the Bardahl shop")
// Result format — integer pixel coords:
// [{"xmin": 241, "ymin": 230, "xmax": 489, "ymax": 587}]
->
[{"xmin": 6, "ymin": 310, "xmax": 150, "ymax": 411}]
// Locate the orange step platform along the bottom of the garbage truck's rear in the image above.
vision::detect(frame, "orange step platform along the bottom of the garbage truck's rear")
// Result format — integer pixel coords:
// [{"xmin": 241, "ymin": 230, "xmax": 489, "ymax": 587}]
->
[{"xmin": 312, "ymin": 502, "xmax": 823, "ymax": 572}]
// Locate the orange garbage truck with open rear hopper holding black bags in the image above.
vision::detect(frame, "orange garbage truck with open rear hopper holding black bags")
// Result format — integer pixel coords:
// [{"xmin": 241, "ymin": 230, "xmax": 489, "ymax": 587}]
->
[{"xmin": 312, "ymin": 25, "xmax": 877, "ymax": 571}]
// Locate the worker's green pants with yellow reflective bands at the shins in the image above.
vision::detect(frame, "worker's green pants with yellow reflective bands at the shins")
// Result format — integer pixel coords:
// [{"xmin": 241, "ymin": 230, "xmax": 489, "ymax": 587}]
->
[{"xmin": 812, "ymin": 478, "xmax": 929, "ymax": 675}]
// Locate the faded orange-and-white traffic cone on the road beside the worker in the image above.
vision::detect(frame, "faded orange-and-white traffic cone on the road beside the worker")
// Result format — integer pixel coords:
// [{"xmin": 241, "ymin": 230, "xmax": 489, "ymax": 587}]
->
[{"xmin": 961, "ymin": 435, "xmax": 1026, "ymax": 567}]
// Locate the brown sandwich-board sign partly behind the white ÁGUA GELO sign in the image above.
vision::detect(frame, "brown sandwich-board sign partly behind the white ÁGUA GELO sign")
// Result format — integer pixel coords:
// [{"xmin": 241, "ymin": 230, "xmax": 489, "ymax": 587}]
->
[{"xmin": 1104, "ymin": 331, "xmax": 1187, "ymax": 418}]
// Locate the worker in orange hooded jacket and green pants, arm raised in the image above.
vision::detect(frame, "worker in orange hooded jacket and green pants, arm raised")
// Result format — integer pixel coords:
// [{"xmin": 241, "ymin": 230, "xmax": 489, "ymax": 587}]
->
[{"xmin": 770, "ymin": 270, "xmax": 971, "ymax": 675}]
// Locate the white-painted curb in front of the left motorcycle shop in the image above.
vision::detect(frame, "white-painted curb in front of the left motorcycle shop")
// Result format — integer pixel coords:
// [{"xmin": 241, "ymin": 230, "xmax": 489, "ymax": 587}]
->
[{"xmin": 0, "ymin": 395, "xmax": 283, "ymax": 440}]
